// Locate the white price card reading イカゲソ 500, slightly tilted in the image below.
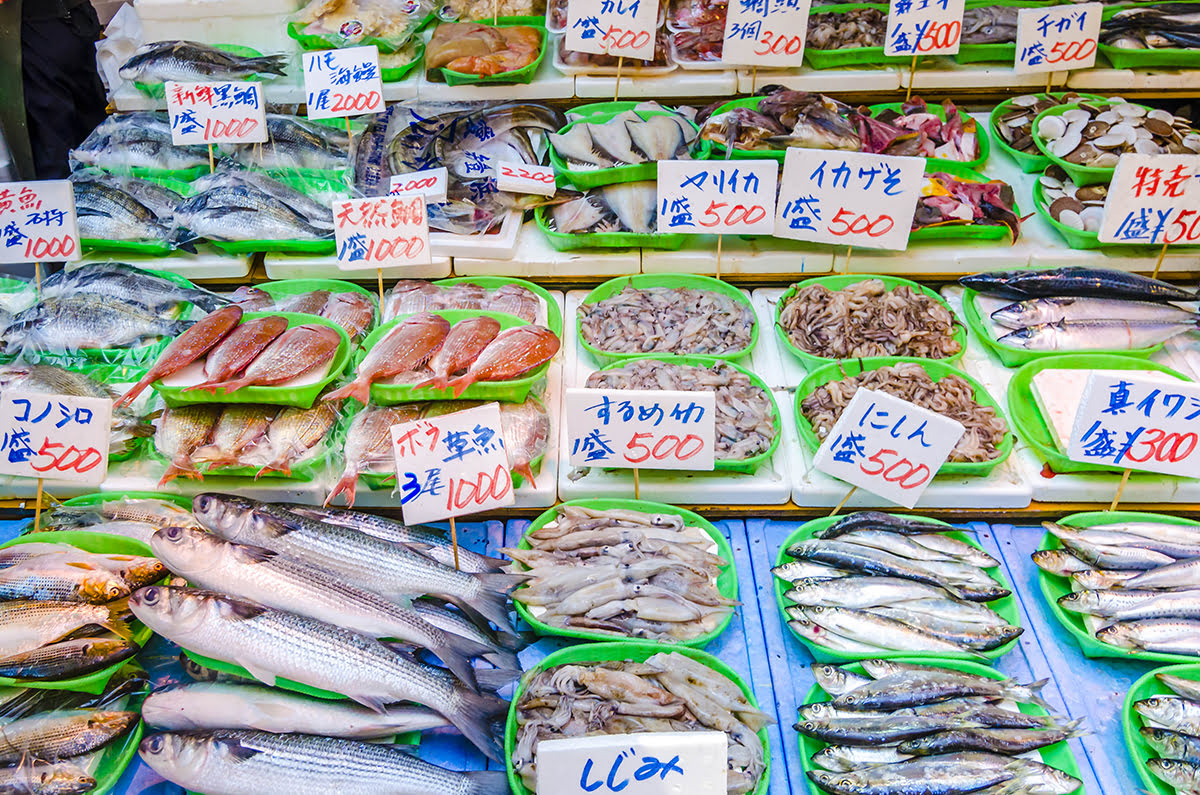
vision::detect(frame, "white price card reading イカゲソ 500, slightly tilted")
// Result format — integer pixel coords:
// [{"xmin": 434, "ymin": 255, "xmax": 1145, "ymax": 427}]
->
[{"xmin": 775, "ymin": 149, "xmax": 925, "ymax": 250}]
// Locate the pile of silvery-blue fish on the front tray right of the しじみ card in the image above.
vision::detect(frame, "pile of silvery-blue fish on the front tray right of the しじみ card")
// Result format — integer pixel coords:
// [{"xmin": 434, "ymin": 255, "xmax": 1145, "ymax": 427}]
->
[{"xmin": 796, "ymin": 659, "xmax": 1082, "ymax": 795}]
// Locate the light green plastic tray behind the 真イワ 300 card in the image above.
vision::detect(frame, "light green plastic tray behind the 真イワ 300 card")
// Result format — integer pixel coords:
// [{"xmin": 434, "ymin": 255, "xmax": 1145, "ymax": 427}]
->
[{"xmin": 1008, "ymin": 353, "xmax": 1190, "ymax": 478}]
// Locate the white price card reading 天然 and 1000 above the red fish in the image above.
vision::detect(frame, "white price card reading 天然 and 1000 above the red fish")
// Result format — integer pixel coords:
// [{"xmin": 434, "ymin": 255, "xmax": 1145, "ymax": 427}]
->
[{"xmin": 334, "ymin": 195, "xmax": 431, "ymax": 270}]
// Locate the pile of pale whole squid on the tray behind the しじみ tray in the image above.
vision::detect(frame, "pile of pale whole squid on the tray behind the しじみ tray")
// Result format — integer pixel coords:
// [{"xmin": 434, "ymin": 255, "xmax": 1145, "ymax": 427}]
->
[{"xmin": 500, "ymin": 506, "xmax": 738, "ymax": 642}]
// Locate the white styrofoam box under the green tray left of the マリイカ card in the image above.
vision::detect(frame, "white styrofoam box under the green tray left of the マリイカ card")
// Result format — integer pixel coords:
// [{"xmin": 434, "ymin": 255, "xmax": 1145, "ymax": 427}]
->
[{"xmin": 454, "ymin": 221, "xmax": 642, "ymax": 279}]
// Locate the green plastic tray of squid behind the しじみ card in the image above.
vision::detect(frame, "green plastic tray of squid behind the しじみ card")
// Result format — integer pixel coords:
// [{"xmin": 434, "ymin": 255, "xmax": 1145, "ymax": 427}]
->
[{"xmin": 504, "ymin": 641, "xmax": 772, "ymax": 795}]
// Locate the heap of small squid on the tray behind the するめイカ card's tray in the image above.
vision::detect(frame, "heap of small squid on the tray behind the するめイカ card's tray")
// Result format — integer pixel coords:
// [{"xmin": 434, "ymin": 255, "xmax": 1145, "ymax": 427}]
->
[{"xmin": 578, "ymin": 285, "xmax": 755, "ymax": 355}]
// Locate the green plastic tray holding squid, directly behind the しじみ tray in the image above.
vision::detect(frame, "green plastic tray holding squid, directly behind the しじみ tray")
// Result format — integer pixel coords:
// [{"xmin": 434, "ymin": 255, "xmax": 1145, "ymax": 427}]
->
[{"xmin": 512, "ymin": 498, "xmax": 738, "ymax": 648}]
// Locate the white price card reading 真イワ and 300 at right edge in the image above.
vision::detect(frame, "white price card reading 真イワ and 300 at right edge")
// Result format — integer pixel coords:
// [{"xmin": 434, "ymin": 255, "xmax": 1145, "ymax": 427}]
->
[{"xmin": 1067, "ymin": 370, "xmax": 1200, "ymax": 478}]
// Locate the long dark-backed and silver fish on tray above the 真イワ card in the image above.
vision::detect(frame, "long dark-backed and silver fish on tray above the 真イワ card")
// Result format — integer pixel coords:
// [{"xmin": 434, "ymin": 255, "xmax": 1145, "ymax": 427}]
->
[{"xmin": 959, "ymin": 268, "xmax": 1200, "ymax": 351}]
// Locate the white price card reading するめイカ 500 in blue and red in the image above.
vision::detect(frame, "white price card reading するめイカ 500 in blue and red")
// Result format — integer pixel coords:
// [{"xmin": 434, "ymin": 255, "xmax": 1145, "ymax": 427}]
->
[{"xmin": 566, "ymin": 389, "xmax": 716, "ymax": 472}]
